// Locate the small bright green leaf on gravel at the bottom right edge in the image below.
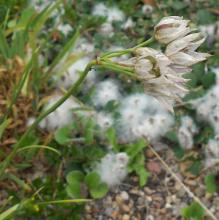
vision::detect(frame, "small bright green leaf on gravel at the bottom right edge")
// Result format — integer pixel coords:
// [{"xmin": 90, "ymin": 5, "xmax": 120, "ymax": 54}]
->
[{"xmin": 181, "ymin": 202, "xmax": 205, "ymax": 220}]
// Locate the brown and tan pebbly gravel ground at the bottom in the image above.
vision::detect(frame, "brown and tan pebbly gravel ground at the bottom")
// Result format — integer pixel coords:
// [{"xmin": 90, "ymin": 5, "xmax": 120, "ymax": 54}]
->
[{"xmin": 84, "ymin": 149, "xmax": 219, "ymax": 220}]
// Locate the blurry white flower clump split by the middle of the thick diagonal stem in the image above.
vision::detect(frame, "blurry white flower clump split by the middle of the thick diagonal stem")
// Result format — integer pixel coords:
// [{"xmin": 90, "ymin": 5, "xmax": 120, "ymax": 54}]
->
[{"xmin": 39, "ymin": 94, "xmax": 79, "ymax": 131}]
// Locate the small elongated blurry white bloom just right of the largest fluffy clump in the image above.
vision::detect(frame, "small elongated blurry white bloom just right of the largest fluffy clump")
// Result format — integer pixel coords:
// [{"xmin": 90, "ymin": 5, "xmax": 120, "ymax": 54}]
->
[{"xmin": 177, "ymin": 116, "xmax": 198, "ymax": 150}]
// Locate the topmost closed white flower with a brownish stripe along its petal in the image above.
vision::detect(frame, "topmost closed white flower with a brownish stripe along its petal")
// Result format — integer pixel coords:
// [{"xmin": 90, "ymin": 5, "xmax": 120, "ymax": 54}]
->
[{"xmin": 154, "ymin": 16, "xmax": 191, "ymax": 44}]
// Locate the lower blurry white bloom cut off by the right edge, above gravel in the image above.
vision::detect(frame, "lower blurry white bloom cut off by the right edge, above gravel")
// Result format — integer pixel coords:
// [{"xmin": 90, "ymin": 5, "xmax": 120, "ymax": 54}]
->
[{"xmin": 205, "ymin": 137, "xmax": 219, "ymax": 168}]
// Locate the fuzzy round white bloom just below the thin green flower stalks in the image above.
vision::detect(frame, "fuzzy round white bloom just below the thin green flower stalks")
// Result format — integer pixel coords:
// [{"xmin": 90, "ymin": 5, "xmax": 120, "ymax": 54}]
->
[{"xmin": 92, "ymin": 79, "xmax": 121, "ymax": 107}]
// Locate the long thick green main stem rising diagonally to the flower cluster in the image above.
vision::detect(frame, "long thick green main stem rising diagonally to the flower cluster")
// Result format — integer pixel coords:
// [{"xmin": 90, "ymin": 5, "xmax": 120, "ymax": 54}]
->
[{"xmin": 0, "ymin": 60, "xmax": 96, "ymax": 179}]
